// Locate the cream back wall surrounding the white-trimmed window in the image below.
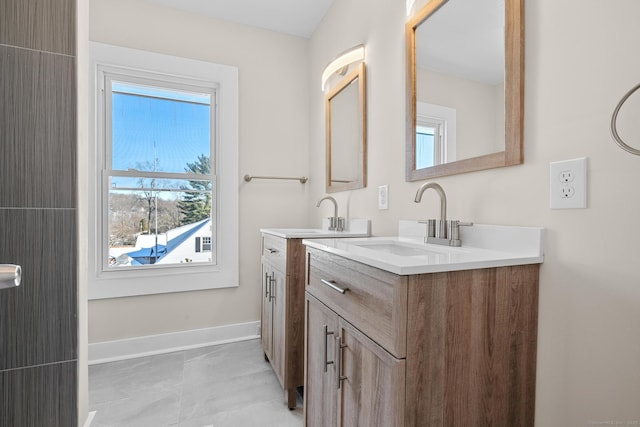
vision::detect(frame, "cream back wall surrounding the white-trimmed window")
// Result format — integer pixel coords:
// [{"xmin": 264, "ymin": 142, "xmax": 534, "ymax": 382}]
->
[{"xmin": 89, "ymin": 0, "xmax": 309, "ymax": 343}]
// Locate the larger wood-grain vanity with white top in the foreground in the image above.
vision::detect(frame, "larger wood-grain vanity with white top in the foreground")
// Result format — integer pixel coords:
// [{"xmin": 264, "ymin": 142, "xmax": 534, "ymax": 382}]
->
[{"xmin": 304, "ymin": 226, "xmax": 542, "ymax": 427}]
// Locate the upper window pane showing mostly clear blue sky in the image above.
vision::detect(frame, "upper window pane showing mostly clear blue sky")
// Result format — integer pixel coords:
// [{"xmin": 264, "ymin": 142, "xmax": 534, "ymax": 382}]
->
[{"xmin": 111, "ymin": 81, "xmax": 211, "ymax": 173}]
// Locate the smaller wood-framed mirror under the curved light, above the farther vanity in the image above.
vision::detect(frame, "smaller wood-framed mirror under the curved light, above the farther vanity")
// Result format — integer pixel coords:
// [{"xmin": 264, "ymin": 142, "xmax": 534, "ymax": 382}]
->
[{"xmin": 325, "ymin": 62, "xmax": 366, "ymax": 192}]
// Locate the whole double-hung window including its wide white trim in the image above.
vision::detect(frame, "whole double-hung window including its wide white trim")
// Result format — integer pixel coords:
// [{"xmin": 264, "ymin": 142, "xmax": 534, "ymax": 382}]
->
[{"xmin": 89, "ymin": 43, "xmax": 238, "ymax": 299}]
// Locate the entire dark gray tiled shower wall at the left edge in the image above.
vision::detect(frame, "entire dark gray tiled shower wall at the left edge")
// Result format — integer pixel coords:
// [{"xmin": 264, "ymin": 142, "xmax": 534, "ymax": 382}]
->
[{"xmin": 0, "ymin": 0, "xmax": 78, "ymax": 427}]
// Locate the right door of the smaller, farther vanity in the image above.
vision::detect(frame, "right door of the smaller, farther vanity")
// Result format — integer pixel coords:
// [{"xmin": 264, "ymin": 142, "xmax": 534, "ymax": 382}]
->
[{"xmin": 268, "ymin": 268, "xmax": 287, "ymax": 386}]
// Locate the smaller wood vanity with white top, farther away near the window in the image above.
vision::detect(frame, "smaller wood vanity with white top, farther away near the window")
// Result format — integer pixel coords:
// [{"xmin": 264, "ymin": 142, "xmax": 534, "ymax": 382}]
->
[{"xmin": 260, "ymin": 220, "xmax": 370, "ymax": 409}]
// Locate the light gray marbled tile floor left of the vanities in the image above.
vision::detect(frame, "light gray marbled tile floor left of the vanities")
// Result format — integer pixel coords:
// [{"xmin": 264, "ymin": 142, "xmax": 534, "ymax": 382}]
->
[{"xmin": 89, "ymin": 340, "xmax": 303, "ymax": 427}]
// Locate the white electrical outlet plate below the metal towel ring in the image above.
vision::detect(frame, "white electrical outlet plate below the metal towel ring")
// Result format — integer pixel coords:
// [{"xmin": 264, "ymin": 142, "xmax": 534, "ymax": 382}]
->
[{"xmin": 549, "ymin": 157, "xmax": 587, "ymax": 209}]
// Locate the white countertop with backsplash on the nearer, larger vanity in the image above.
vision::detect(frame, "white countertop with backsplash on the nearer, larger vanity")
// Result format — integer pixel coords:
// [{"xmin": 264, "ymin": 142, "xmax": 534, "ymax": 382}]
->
[{"xmin": 303, "ymin": 221, "xmax": 544, "ymax": 275}]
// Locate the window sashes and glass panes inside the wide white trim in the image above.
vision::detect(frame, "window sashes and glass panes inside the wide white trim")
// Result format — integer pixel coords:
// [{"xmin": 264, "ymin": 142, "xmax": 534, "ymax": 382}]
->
[{"xmin": 101, "ymin": 75, "xmax": 216, "ymax": 268}]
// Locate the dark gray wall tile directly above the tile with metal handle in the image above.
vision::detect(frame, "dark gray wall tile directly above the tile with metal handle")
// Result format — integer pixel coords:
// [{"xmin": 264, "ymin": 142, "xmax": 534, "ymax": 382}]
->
[{"xmin": 0, "ymin": 46, "xmax": 76, "ymax": 208}]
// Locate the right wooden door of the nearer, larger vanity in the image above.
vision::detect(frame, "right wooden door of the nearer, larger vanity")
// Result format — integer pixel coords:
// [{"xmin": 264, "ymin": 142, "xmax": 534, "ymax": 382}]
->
[{"xmin": 336, "ymin": 319, "xmax": 405, "ymax": 427}]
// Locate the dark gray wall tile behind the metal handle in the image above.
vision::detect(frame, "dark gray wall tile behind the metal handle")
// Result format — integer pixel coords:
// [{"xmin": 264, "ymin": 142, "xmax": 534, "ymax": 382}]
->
[{"xmin": 0, "ymin": 209, "xmax": 78, "ymax": 369}]
